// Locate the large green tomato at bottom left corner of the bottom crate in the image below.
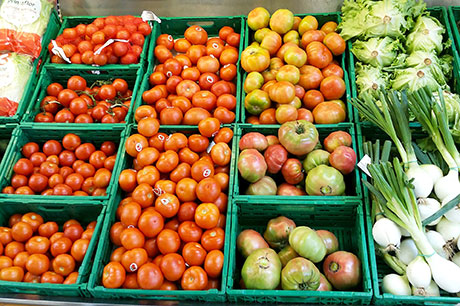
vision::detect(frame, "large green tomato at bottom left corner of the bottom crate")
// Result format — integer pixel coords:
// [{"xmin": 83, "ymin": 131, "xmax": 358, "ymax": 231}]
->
[{"xmin": 241, "ymin": 248, "xmax": 281, "ymax": 290}]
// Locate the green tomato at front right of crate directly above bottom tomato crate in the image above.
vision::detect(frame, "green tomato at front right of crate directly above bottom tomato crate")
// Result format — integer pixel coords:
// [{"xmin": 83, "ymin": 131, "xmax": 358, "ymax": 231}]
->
[{"xmin": 305, "ymin": 165, "xmax": 345, "ymax": 196}]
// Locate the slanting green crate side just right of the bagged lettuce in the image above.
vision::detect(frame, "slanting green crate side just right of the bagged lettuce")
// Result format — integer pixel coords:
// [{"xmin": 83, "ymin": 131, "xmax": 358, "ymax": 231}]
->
[{"xmin": 0, "ymin": 10, "xmax": 61, "ymax": 124}]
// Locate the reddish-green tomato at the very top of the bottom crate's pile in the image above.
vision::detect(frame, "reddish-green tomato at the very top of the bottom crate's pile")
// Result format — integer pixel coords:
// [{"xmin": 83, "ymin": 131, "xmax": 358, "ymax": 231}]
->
[{"xmin": 264, "ymin": 216, "xmax": 296, "ymax": 249}]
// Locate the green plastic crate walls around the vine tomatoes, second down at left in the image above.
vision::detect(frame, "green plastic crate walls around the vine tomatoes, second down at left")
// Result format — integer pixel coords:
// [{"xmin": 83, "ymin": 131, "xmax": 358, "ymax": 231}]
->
[{"xmin": 22, "ymin": 66, "xmax": 144, "ymax": 127}]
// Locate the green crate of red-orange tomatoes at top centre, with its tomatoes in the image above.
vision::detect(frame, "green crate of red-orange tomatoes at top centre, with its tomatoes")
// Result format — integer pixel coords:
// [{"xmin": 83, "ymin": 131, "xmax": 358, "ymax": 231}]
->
[{"xmin": 135, "ymin": 16, "xmax": 244, "ymax": 126}]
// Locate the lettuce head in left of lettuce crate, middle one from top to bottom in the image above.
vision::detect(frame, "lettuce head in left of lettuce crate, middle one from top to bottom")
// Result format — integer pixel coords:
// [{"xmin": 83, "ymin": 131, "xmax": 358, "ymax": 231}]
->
[{"xmin": 351, "ymin": 37, "xmax": 401, "ymax": 68}]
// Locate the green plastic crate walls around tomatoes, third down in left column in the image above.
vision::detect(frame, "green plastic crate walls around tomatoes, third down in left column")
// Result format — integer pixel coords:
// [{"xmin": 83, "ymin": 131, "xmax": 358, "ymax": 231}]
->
[{"xmin": 0, "ymin": 123, "xmax": 125, "ymax": 205}]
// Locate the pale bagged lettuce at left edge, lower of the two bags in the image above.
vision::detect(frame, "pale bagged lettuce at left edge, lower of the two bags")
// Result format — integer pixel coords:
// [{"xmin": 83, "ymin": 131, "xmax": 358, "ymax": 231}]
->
[{"xmin": 0, "ymin": 53, "xmax": 32, "ymax": 103}]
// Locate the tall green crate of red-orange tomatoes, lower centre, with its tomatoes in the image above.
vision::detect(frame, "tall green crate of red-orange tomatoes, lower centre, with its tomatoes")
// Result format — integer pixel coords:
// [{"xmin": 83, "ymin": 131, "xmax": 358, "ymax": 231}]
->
[{"xmin": 88, "ymin": 123, "xmax": 235, "ymax": 302}]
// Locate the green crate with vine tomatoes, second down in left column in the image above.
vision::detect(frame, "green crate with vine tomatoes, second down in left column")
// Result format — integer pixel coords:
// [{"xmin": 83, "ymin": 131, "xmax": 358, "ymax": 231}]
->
[{"xmin": 22, "ymin": 68, "xmax": 143, "ymax": 126}]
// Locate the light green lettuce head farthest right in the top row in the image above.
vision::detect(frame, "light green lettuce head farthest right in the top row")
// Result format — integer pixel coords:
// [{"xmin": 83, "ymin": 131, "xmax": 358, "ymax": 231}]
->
[{"xmin": 406, "ymin": 16, "xmax": 446, "ymax": 54}]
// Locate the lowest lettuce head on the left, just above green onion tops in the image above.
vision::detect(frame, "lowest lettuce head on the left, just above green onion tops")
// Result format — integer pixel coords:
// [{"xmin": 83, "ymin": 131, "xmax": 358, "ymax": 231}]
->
[{"xmin": 355, "ymin": 62, "xmax": 389, "ymax": 99}]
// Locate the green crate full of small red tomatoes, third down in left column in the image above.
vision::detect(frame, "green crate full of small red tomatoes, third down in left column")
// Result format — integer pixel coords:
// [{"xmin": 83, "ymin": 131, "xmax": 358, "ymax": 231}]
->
[{"xmin": 0, "ymin": 124, "xmax": 124, "ymax": 204}]
